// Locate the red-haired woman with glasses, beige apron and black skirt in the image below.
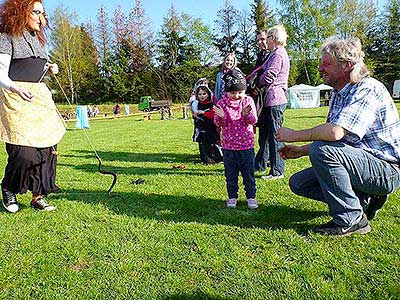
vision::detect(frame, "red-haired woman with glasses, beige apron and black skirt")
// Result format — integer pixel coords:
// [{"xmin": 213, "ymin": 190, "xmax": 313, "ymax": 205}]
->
[{"xmin": 0, "ymin": 0, "xmax": 65, "ymax": 213}]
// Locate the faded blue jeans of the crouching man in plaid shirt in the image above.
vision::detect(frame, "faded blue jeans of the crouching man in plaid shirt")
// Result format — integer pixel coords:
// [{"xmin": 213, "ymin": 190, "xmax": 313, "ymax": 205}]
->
[{"xmin": 289, "ymin": 141, "xmax": 400, "ymax": 226}]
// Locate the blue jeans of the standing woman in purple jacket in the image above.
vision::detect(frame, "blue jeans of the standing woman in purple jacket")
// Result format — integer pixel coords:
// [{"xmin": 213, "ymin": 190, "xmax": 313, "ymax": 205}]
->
[{"xmin": 266, "ymin": 104, "xmax": 286, "ymax": 176}]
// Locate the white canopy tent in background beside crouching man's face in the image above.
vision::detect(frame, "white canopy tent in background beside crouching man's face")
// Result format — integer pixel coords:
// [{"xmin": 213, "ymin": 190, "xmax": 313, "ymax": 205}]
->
[{"xmin": 288, "ymin": 84, "xmax": 332, "ymax": 108}]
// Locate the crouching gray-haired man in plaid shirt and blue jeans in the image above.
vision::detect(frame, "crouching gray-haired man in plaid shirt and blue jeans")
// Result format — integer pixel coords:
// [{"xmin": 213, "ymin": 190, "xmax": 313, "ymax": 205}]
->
[{"xmin": 277, "ymin": 37, "xmax": 400, "ymax": 236}]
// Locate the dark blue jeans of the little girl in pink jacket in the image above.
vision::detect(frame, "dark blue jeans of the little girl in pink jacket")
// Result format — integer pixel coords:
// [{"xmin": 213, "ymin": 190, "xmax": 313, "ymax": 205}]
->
[{"xmin": 223, "ymin": 148, "xmax": 256, "ymax": 199}]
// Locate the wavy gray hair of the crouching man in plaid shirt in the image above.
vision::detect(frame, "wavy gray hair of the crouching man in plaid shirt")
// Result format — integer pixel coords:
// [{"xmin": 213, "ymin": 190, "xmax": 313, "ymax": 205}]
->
[{"xmin": 321, "ymin": 36, "xmax": 369, "ymax": 83}]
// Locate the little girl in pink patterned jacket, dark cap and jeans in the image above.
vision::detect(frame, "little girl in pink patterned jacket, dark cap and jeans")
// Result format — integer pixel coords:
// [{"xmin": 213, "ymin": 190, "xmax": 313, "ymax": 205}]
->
[{"xmin": 214, "ymin": 69, "xmax": 258, "ymax": 209}]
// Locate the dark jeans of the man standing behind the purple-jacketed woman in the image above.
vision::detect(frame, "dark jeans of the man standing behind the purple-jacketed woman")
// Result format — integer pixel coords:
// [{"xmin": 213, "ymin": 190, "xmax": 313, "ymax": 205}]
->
[{"xmin": 254, "ymin": 108, "xmax": 270, "ymax": 172}]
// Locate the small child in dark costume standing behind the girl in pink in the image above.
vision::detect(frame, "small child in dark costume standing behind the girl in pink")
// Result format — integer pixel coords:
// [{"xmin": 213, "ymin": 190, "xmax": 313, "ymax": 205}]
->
[{"xmin": 192, "ymin": 85, "xmax": 222, "ymax": 164}]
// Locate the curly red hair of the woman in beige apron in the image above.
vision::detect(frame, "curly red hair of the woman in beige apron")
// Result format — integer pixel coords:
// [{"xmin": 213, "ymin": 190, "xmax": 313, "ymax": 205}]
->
[{"xmin": 0, "ymin": 0, "xmax": 46, "ymax": 44}]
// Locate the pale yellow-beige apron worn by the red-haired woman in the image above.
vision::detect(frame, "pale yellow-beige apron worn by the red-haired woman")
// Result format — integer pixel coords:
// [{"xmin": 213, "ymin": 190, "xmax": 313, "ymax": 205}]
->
[{"xmin": 0, "ymin": 82, "xmax": 66, "ymax": 148}]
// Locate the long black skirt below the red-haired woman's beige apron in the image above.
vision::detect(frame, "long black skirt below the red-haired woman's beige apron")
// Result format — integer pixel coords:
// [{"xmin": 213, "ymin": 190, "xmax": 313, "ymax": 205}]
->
[{"xmin": 2, "ymin": 143, "xmax": 59, "ymax": 195}]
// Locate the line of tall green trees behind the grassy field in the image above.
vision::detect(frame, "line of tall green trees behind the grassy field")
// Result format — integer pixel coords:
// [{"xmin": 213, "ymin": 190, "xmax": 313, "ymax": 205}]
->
[{"xmin": 49, "ymin": 0, "xmax": 400, "ymax": 104}]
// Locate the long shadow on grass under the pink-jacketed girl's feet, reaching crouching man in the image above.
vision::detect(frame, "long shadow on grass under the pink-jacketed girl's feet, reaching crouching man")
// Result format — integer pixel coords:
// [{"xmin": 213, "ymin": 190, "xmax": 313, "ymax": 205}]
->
[{"xmin": 51, "ymin": 189, "xmax": 326, "ymax": 235}]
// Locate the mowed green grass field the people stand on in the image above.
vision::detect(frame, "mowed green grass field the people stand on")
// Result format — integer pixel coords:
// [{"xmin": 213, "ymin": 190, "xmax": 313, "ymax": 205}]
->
[{"xmin": 0, "ymin": 107, "xmax": 400, "ymax": 300}]
